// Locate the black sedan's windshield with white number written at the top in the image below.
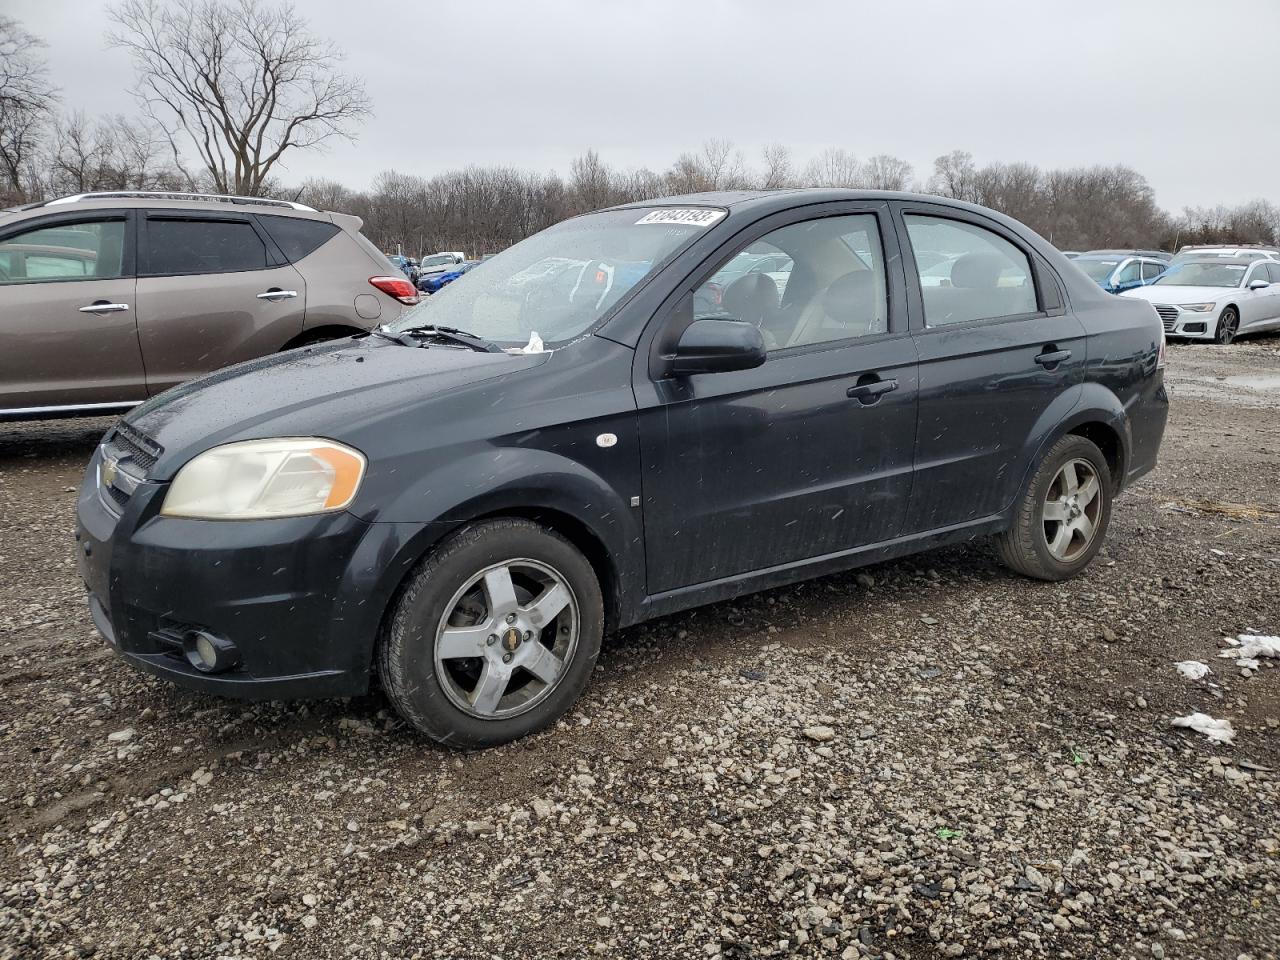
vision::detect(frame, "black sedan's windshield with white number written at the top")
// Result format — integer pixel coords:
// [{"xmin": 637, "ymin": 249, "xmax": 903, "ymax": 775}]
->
[{"xmin": 392, "ymin": 207, "xmax": 724, "ymax": 347}]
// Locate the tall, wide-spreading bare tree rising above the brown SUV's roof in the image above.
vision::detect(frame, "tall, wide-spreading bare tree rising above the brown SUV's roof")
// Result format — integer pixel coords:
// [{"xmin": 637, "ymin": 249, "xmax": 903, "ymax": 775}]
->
[{"xmin": 110, "ymin": 0, "xmax": 370, "ymax": 196}]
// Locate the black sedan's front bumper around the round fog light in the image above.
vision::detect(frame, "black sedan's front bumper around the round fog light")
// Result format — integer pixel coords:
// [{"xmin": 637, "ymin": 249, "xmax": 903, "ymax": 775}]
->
[{"xmin": 76, "ymin": 452, "xmax": 445, "ymax": 699}]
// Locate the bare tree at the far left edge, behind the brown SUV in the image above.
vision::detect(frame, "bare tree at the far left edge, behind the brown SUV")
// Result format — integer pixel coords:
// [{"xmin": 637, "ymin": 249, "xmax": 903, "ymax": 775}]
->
[{"xmin": 0, "ymin": 17, "xmax": 58, "ymax": 200}]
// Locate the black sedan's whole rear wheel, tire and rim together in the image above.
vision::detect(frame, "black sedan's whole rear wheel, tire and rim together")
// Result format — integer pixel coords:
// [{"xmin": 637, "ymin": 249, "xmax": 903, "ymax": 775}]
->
[{"xmin": 996, "ymin": 435, "xmax": 1115, "ymax": 581}]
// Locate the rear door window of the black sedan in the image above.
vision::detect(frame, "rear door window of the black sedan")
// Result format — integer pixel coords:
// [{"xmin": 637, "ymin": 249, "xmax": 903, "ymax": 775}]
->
[{"xmin": 904, "ymin": 214, "xmax": 1038, "ymax": 326}]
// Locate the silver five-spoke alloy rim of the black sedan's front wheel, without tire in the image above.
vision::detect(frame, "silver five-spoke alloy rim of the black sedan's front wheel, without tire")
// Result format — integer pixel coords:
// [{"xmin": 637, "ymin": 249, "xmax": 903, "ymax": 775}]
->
[{"xmin": 434, "ymin": 559, "xmax": 580, "ymax": 719}]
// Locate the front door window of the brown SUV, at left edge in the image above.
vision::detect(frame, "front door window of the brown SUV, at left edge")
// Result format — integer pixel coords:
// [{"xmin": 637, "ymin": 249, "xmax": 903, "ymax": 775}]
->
[{"xmin": 0, "ymin": 219, "xmax": 124, "ymax": 284}]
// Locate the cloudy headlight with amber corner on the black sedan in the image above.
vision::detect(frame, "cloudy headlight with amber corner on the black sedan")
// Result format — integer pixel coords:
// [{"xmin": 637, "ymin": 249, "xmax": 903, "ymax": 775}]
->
[{"xmin": 160, "ymin": 438, "xmax": 365, "ymax": 520}]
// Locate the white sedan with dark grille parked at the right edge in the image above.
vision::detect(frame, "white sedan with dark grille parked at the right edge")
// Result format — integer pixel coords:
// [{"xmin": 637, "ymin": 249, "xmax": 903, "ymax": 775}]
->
[{"xmin": 1120, "ymin": 256, "xmax": 1280, "ymax": 343}]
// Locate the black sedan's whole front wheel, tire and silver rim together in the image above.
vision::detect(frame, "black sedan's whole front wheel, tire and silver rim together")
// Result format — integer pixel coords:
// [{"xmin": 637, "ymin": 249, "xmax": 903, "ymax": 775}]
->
[{"xmin": 376, "ymin": 517, "xmax": 604, "ymax": 749}]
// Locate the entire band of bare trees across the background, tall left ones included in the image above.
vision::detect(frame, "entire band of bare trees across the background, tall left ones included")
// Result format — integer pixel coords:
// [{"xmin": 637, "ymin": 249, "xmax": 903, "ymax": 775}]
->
[{"xmin": 0, "ymin": 6, "xmax": 1280, "ymax": 256}]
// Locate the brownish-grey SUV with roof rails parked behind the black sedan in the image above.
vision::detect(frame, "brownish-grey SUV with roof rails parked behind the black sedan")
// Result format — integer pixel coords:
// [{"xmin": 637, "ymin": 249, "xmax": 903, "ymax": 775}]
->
[{"xmin": 0, "ymin": 192, "xmax": 417, "ymax": 420}]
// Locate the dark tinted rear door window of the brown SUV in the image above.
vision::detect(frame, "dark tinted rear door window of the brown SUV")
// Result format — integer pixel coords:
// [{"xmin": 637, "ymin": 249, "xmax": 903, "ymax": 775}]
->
[{"xmin": 146, "ymin": 218, "xmax": 266, "ymax": 275}]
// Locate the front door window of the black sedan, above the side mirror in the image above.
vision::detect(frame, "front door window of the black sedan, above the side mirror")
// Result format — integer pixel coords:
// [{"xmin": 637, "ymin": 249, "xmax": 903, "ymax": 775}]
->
[{"xmin": 694, "ymin": 214, "xmax": 888, "ymax": 351}]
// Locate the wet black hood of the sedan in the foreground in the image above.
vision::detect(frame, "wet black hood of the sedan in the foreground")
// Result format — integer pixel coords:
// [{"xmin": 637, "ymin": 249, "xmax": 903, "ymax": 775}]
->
[{"xmin": 113, "ymin": 337, "xmax": 549, "ymax": 480}]
